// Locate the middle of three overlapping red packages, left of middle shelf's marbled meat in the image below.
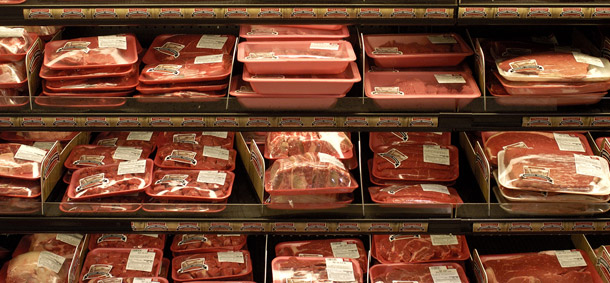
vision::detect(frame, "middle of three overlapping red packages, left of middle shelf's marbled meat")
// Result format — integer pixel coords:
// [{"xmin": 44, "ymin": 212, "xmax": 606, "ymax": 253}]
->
[{"xmin": 155, "ymin": 143, "xmax": 237, "ymax": 171}]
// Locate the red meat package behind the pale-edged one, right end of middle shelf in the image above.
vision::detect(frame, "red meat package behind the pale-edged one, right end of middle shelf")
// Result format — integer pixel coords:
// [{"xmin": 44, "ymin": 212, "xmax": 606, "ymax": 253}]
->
[{"xmin": 481, "ymin": 132, "xmax": 593, "ymax": 166}]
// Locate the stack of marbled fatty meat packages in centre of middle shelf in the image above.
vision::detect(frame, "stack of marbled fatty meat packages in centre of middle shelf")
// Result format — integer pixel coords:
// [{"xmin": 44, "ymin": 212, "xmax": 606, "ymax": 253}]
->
[{"xmin": 264, "ymin": 132, "xmax": 358, "ymax": 209}]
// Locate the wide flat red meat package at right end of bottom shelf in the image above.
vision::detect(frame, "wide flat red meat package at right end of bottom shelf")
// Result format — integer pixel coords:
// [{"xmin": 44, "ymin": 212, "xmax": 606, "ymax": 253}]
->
[{"xmin": 480, "ymin": 250, "xmax": 603, "ymax": 283}]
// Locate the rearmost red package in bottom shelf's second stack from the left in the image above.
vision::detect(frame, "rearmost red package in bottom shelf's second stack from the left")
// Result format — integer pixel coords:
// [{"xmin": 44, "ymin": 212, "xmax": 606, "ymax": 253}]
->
[{"xmin": 89, "ymin": 234, "xmax": 165, "ymax": 250}]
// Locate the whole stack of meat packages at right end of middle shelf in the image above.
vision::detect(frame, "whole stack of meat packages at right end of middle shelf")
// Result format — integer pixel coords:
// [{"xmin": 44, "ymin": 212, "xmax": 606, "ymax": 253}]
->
[{"xmin": 481, "ymin": 132, "xmax": 610, "ymax": 215}]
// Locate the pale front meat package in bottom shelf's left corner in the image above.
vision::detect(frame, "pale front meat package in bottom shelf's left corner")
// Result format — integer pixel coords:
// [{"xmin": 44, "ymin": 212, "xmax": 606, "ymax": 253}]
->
[{"xmin": 6, "ymin": 251, "xmax": 70, "ymax": 283}]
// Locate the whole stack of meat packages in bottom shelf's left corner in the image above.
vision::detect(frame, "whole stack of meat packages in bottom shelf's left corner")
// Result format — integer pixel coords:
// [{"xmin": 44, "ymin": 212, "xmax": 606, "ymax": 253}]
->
[{"xmin": 0, "ymin": 234, "xmax": 83, "ymax": 283}]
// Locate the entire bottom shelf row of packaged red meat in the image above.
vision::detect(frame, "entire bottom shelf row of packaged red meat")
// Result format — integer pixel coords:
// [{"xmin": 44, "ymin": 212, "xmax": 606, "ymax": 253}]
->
[{"xmin": 0, "ymin": 234, "xmax": 610, "ymax": 283}]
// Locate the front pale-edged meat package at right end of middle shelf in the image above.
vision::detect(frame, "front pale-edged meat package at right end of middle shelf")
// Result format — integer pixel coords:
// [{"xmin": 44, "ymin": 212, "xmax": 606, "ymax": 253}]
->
[{"xmin": 498, "ymin": 147, "xmax": 610, "ymax": 196}]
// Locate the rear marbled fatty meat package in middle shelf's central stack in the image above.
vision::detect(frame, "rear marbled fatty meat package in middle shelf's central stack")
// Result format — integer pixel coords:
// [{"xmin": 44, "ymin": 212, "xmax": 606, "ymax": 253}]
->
[{"xmin": 265, "ymin": 132, "xmax": 354, "ymax": 159}]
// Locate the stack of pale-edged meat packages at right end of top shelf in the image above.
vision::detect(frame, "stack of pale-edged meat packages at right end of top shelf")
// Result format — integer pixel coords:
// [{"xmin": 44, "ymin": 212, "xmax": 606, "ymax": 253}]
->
[{"xmin": 483, "ymin": 40, "xmax": 610, "ymax": 106}]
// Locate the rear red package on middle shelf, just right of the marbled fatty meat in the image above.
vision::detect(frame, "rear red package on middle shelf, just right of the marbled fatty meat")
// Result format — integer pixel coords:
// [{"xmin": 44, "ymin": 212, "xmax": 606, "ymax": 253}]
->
[{"xmin": 369, "ymin": 132, "xmax": 451, "ymax": 152}]
